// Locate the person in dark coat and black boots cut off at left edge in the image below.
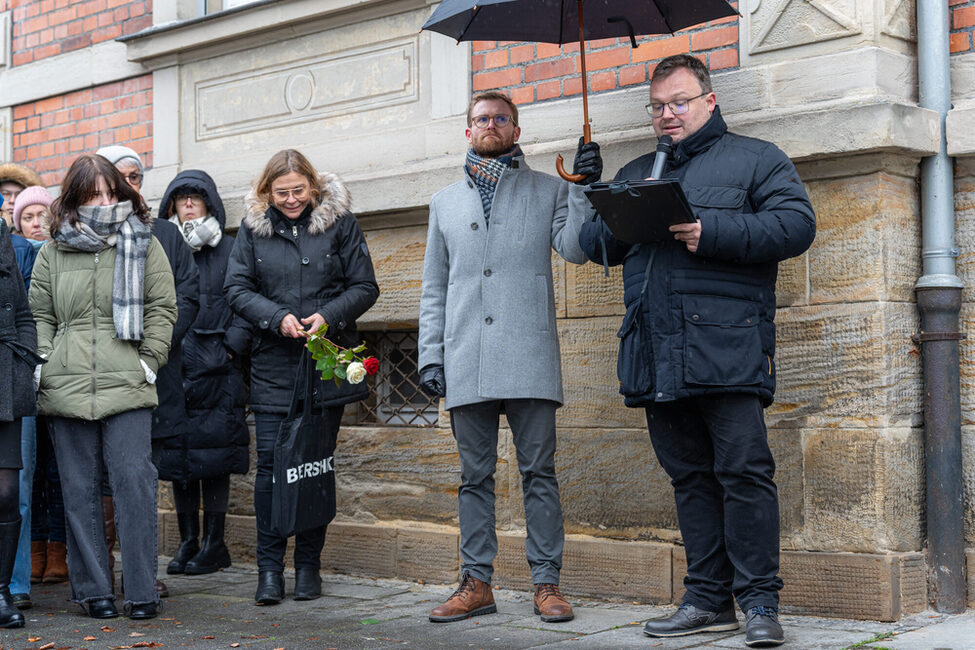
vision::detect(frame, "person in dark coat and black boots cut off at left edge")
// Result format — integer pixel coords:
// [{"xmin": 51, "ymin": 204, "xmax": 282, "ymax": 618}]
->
[{"xmin": 0, "ymin": 220, "xmax": 40, "ymax": 628}]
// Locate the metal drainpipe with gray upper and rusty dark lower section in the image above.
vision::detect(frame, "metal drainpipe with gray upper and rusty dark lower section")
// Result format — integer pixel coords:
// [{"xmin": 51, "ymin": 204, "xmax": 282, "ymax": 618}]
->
[{"xmin": 915, "ymin": 0, "xmax": 967, "ymax": 613}]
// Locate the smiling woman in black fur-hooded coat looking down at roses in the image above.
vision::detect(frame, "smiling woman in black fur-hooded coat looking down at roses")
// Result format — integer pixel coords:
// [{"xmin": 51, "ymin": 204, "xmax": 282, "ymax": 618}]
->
[{"xmin": 224, "ymin": 149, "xmax": 379, "ymax": 605}]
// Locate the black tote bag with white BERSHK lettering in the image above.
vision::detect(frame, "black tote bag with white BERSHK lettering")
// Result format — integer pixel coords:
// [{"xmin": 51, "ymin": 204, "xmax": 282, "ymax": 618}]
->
[{"xmin": 271, "ymin": 351, "xmax": 338, "ymax": 537}]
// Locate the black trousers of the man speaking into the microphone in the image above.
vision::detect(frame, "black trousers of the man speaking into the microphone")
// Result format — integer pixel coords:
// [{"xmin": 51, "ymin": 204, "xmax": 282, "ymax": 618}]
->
[{"xmin": 646, "ymin": 394, "xmax": 782, "ymax": 612}]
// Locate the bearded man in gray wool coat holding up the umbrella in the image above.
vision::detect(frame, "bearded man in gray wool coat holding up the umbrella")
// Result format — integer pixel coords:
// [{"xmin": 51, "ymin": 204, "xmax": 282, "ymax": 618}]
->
[{"xmin": 419, "ymin": 93, "xmax": 602, "ymax": 622}]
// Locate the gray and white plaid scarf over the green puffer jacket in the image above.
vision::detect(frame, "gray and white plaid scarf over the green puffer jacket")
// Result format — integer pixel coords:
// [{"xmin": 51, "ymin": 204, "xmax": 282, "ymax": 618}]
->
[{"xmin": 54, "ymin": 201, "xmax": 152, "ymax": 341}]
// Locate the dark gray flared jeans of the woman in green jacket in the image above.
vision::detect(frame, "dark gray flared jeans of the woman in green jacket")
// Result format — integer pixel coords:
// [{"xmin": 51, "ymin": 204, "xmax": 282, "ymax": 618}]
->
[{"xmin": 51, "ymin": 409, "xmax": 159, "ymax": 607}]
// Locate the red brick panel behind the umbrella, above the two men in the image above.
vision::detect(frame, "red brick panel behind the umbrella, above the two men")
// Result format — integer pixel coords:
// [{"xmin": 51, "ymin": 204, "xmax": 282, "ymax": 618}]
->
[{"xmin": 472, "ymin": 3, "xmax": 738, "ymax": 104}]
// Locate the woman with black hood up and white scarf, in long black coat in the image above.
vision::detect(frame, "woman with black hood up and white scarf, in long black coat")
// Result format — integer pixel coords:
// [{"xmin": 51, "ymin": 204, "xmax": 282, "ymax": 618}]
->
[{"xmin": 155, "ymin": 169, "xmax": 250, "ymax": 575}]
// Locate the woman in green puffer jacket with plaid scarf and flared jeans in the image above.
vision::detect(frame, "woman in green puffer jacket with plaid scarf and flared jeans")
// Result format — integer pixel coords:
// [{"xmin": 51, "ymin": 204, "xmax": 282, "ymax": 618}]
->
[{"xmin": 30, "ymin": 155, "xmax": 176, "ymax": 619}]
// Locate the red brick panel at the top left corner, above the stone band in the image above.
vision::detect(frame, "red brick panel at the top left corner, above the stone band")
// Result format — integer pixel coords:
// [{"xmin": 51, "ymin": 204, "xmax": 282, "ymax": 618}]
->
[{"xmin": 0, "ymin": 0, "xmax": 152, "ymax": 66}]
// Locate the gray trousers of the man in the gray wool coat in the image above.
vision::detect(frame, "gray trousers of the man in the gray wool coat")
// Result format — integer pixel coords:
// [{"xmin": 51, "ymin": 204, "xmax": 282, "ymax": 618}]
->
[{"xmin": 450, "ymin": 399, "xmax": 565, "ymax": 584}]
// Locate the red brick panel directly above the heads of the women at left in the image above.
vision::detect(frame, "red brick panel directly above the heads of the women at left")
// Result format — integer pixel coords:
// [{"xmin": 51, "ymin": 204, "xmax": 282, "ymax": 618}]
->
[{"xmin": 13, "ymin": 74, "xmax": 152, "ymax": 185}]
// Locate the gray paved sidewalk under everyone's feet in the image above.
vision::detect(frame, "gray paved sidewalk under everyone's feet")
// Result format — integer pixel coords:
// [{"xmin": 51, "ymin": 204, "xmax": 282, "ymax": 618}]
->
[{"xmin": 0, "ymin": 560, "xmax": 975, "ymax": 650}]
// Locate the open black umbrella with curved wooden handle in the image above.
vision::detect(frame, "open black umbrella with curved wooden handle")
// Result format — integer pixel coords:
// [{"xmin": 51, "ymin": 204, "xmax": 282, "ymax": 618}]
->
[{"xmin": 422, "ymin": 0, "xmax": 738, "ymax": 180}]
